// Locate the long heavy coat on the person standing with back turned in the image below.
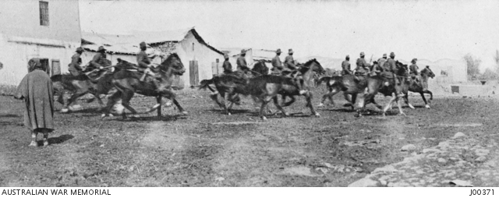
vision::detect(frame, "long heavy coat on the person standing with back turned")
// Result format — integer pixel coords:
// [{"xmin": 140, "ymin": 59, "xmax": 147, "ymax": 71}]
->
[{"xmin": 16, "ymin": 69, "xmax": 54, "ymax": 130}]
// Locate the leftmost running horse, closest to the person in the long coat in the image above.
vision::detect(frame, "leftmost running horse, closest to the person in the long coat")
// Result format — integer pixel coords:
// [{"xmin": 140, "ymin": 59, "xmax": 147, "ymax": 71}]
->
[{"xmin": 50, "ymin": 62, "xmax": 120, "ymax": 113}]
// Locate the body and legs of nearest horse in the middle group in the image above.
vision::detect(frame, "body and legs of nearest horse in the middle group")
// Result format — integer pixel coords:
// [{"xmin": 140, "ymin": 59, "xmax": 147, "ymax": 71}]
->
[{"xmin": 247, "ymin": 75, "xmax": 319, "ymax": 120}]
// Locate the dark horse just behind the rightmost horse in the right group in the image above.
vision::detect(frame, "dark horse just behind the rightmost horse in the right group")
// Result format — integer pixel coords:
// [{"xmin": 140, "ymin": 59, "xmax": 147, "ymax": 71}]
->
[{"xmin": 356, "ymin": 61, "xmax": 410, "ymax": 117}]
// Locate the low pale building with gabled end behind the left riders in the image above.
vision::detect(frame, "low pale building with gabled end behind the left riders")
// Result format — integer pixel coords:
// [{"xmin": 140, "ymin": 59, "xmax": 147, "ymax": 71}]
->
[{"xmin": 82, "ymin": 27, "xmax": 223, "ymax": 86}]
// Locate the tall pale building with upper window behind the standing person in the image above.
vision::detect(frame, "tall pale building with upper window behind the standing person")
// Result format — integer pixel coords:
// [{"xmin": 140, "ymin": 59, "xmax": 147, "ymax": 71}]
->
[{"xmin": 0, "ymin": 0, "xmax": 81, "ymax": 85}]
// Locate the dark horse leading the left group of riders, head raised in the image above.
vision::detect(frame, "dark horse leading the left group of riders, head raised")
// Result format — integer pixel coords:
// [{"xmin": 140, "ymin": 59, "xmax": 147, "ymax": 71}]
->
[{"xmin": 102, "ymin": 53, "xmax": 187, "ymax": 118}]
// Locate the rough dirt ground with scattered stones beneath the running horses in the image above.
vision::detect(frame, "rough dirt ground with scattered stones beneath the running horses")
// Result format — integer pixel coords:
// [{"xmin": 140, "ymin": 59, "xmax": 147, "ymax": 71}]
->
[{"xmin": 0, "ymin": 89, "xmax": 499, "ymax": 187}]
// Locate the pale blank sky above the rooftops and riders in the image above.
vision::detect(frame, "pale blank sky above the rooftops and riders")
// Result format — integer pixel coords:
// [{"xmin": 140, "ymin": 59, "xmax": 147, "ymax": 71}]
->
[{"xmin": 80, "ymin": 0, "xmax": 499, "ymax": 71}]
